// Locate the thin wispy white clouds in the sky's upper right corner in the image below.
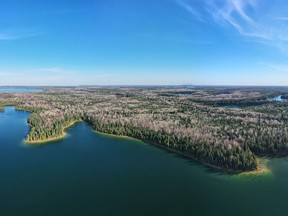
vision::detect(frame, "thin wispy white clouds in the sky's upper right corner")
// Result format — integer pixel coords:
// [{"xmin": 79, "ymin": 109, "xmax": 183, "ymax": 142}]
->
[{"xmin": 177, "ymin": 0, "xmax": 288, "ymax": 54}]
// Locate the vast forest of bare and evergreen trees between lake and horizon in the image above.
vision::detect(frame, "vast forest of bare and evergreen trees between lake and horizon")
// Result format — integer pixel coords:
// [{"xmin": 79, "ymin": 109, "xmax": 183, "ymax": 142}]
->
[{"xmin": 0, "ymin": 87, "xmax": 288, "ymax": 172}]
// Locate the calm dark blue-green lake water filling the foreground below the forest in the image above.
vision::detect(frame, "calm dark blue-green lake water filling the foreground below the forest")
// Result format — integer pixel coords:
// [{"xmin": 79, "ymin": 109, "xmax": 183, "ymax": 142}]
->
[{"xmin": 0, "ymin": 107, "xmax": 288, "ymax": 216}]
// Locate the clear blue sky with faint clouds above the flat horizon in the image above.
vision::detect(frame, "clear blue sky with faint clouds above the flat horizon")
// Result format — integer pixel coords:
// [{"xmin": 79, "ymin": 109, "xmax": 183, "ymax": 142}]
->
[{"xmin": 0, "ymin": 0, "xmax": 288, "ymax": 86}]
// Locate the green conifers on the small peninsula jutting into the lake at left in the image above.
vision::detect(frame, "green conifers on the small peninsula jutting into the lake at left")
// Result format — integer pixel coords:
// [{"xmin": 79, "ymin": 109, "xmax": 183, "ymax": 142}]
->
[{"xmin": 26, "ymin": 113, "xmax": 81, "ymax": 142}]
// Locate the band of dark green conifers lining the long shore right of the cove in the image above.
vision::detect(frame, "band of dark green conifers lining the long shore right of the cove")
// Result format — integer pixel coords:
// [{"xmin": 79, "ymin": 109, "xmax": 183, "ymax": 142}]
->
[{"xmin": 84, "ymin": 117, "xmax": 257, "ymax": 172}]
